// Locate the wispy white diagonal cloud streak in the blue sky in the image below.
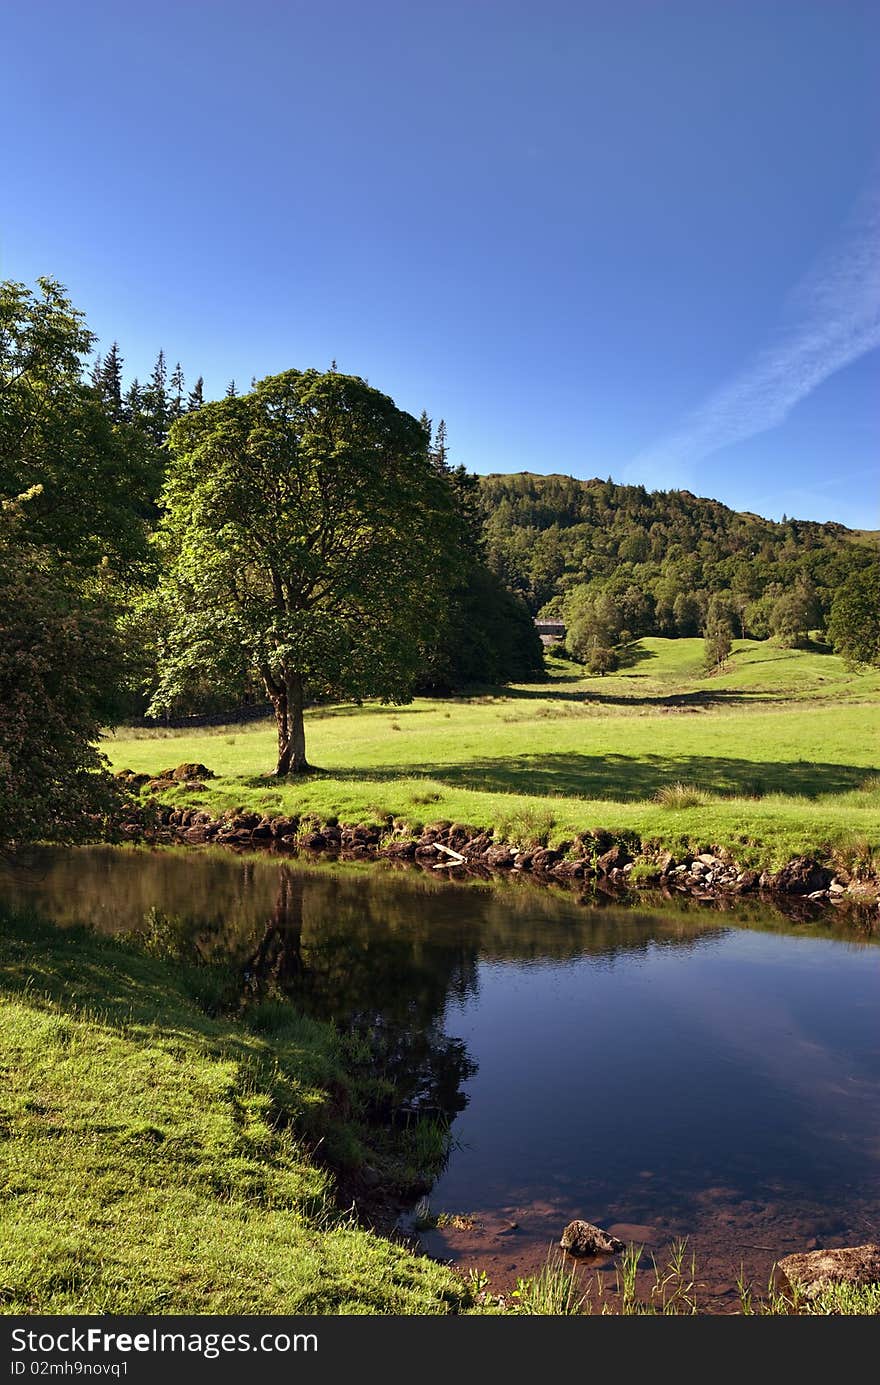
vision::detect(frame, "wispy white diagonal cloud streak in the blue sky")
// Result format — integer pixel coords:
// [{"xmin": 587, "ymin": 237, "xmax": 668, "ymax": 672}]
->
[{"xmin": 626, "ymin": 186, "xmax": 880, "ymax": 485}]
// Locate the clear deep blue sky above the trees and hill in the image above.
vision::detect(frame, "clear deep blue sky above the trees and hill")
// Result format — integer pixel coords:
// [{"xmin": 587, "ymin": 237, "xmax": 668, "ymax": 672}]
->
[{"xmin": 0, "ymin": 0, "xmax": 880, "ymax": 528}]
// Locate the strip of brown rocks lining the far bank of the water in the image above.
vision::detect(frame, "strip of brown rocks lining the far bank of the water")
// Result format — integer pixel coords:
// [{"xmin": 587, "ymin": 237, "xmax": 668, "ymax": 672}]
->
[{"xmin": 118, "ymin": 765, "xmax": 880, "ymax": 911}]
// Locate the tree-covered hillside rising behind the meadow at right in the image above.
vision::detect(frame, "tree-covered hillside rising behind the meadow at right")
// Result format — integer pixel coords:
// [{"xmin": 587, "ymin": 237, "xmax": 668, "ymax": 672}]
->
[{"xmin": 479, "ymin": 472, "xmax": 877, "ymax": 653}]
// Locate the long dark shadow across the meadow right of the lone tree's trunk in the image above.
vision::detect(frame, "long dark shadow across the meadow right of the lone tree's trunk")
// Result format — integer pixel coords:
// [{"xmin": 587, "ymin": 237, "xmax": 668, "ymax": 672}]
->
[{"xmin": 291, "ymin": 752, "xmax": 870, "ymax": 802}]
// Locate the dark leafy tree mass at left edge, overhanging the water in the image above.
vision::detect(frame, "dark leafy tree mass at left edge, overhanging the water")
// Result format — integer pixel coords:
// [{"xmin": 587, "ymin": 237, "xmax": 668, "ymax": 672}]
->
[{"xmin": 0, "ymin": 278, "xmax": 166, "ymax": 846}]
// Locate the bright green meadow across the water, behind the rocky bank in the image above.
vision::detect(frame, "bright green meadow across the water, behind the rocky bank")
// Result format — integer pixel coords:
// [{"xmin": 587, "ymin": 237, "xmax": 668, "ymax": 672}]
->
[{"xmin": 104, "ymin": 638, "xmax": 880, "ymax": 866}]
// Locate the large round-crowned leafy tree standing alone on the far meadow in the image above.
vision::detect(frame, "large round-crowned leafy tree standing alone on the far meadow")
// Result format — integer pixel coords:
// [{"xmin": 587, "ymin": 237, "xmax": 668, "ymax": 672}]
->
[{"xmin": 154, "ymin": 370, "xmax": 460, "ymax": 774}]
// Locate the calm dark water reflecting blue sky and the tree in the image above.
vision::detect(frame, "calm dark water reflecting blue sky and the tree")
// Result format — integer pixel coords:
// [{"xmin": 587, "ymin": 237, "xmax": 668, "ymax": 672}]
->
[{"xmin": 0, "ymin": 848, "xmax": 880, "ymax": 1295}]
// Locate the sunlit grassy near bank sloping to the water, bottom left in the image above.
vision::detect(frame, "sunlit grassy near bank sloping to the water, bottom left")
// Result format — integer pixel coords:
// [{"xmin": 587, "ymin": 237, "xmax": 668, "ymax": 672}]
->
[{"xmin": 0, "ymin": 915, "xmax": 466, "ymax": 1313}]
